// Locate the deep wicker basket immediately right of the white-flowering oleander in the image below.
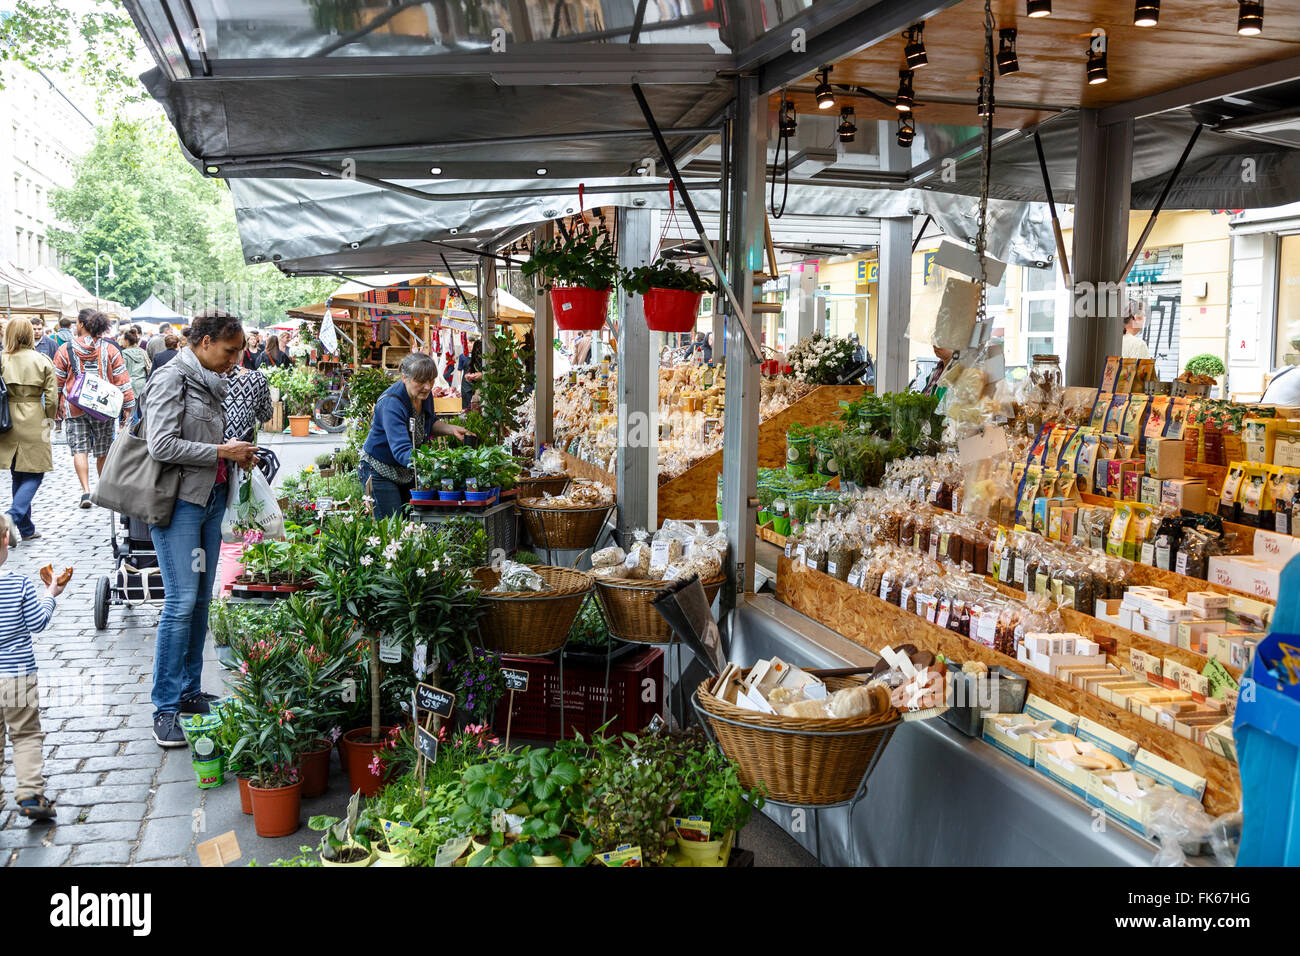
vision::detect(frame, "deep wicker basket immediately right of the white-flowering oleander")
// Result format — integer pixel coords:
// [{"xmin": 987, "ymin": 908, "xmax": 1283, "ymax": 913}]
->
[{"xmin": 475, "ymin": 564, "xmax": 592, "ymax": 657}]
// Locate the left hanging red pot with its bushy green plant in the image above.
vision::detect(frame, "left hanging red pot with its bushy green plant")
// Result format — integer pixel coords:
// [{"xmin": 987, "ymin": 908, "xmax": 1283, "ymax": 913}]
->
[{"xmin": 520, "ymin": 228, "xmax": 623, "ymax": 332}]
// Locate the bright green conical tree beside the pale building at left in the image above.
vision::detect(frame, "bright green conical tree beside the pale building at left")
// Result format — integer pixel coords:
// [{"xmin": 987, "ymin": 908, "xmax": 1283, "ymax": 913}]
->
[{"xmin": 66, "ymin": 185, "xmax": 166, "ymax": 306}]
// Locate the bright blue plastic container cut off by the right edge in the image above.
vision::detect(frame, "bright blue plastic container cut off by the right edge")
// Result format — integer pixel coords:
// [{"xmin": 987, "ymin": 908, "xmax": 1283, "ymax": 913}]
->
[{"xmin": 1232, "ymin": 633, "xmax": 1300, "ymax": 866}]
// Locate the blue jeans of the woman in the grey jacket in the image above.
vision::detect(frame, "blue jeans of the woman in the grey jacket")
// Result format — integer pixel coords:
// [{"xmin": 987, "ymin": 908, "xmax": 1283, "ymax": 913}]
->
[{"xmin": 150, "ymin": 484, "xmax": 226, "ymax": 717}]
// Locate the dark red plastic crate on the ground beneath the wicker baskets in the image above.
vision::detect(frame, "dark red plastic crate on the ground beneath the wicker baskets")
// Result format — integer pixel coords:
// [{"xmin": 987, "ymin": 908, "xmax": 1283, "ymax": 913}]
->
[{"xmin": 493, "ymin": 648, "xmax": 664, "ymax": 740}]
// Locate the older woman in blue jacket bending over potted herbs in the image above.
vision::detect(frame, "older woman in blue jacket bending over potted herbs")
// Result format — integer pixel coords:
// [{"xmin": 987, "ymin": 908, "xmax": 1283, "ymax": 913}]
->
[{"xmin": 360, "ymin": 352, "xmax": 467, "ymax": 518}]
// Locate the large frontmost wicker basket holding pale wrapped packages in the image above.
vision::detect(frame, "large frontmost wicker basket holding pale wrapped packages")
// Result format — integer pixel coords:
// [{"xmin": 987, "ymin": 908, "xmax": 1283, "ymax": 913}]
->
[{"xmin": 696, "ymin": 671, "xmax": 902, "ymax": 806}]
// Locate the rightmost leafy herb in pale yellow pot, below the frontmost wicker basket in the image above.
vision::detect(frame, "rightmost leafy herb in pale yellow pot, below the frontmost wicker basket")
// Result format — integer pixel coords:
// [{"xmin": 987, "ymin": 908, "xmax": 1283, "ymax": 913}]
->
[{"xmin": 675, "ymin": 737, "xmax": 763, "ymax": 866}]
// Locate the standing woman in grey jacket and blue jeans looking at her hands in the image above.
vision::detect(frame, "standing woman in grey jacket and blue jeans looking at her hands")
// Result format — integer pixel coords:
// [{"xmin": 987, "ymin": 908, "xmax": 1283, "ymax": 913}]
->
[{"xmin": 142, "ymin": 311, "xmax": 257, "ymax": 747}]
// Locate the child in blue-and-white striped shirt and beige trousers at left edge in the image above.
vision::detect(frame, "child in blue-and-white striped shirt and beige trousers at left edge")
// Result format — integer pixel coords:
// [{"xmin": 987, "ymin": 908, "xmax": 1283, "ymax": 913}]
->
[{"xmin": 0, "ymin": 515, "xmax": 65, "ymax": 819}]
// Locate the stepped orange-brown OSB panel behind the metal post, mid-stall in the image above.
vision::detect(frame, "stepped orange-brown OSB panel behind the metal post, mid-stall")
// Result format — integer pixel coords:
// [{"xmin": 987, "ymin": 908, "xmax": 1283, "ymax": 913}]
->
[{"xmin": 659, "ymin": 385, "xmax": 867, "ymax": 522}]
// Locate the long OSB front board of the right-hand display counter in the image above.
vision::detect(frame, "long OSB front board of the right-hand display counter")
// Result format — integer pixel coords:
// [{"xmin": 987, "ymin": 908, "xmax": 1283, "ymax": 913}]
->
[{"xmin": 776, "ymin": 555, "xmax": 1242, "ymax": 814}]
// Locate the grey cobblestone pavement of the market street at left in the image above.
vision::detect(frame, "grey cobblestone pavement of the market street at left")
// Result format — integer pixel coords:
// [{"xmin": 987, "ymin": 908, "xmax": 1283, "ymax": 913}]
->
[{"xmin": 0, "ymin": 436, "xmax": 347, "ymax": 866}]
